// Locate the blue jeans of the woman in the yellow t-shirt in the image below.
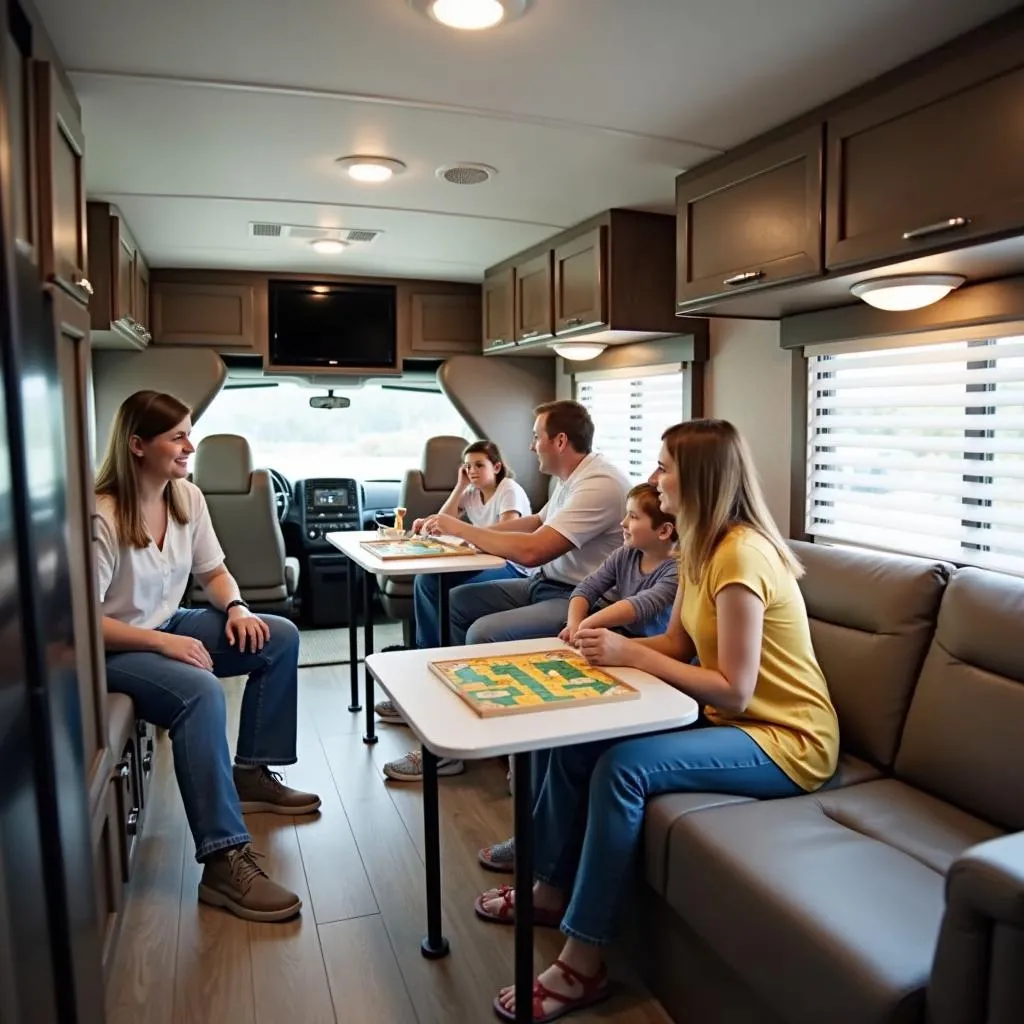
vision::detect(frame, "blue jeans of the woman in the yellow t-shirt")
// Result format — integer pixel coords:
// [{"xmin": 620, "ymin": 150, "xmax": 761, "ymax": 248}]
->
[{"xmin": 534, "ymin": 726, "xmax": 804, "ymax": 945}]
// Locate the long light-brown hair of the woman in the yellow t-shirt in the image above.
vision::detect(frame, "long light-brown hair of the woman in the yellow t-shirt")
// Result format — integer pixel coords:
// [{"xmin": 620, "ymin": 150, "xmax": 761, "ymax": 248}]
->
[{"xmin": 662, "ymin": 420, "xmax": 804, "ymax": 584}]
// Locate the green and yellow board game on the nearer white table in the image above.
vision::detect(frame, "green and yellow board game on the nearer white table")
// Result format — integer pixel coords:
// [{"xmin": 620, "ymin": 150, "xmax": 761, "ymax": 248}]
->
[{"xmin": 430, "ymin": 649, "xmax": 640, "ymax": 718}]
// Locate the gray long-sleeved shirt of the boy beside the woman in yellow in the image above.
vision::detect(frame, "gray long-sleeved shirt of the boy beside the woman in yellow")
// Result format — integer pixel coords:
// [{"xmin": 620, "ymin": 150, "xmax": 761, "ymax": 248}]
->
[{"xmin": 570, "ymin": 548, "xmax": 679, "ymax": 636}]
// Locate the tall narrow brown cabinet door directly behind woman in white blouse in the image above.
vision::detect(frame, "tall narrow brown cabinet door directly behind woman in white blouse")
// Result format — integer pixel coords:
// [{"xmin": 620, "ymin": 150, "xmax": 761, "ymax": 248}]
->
[{"xmin": 53, "ymin": 292, "xmax": 109, "ymax": 793}]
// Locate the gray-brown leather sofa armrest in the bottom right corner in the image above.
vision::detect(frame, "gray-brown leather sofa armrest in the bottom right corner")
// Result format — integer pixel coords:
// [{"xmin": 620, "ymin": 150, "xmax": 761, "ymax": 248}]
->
[{"xmin": 928, "ymin": 833, "xmax": 1024, "ymax": 1024}]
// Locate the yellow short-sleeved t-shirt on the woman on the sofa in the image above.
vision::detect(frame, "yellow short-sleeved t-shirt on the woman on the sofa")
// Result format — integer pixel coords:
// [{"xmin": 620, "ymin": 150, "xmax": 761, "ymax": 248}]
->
[{"xmin": 680, "ymin": 526, "xmax": 839, "ymax": 791}]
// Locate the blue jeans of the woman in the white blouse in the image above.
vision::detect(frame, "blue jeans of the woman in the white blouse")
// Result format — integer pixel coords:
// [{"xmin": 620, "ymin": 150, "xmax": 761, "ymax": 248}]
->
[{"xmin": 106, "ymin": 608, "xmax": 299, "ymax": 860}]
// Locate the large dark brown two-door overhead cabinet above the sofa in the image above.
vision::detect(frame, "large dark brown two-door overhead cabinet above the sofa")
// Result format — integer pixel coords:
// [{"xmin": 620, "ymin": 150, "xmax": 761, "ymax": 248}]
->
[{"xmin": 676, "ymin": 15, "xmax": 1024, "ymax": 316}]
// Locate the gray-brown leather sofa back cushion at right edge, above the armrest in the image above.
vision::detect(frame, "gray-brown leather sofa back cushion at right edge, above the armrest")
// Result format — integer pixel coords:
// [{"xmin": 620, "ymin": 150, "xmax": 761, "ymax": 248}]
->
[{"xmin": 896, "ymin": 568, "xmax": 1024, "ymax": 831}]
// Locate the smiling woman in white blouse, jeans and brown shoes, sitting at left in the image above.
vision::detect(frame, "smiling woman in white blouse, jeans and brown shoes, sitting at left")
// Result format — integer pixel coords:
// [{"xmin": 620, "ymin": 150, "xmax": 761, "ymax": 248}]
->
[{"xmin": 95, "ymin": 391, "xmax": 319, "ymax": 921}]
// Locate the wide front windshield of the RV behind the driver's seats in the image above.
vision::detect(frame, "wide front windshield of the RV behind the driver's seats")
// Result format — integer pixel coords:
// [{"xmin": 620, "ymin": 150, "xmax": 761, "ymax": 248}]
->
[{"xmin": 191, "ymin": 383, "xmax": 474, "ymax": 482}]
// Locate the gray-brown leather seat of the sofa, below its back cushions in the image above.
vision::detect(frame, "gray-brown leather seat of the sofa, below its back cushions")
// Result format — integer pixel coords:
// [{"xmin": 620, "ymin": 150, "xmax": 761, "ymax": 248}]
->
[{"xmin": 666, "ymin": 779, "xmax": 997, "ymax": 1024}]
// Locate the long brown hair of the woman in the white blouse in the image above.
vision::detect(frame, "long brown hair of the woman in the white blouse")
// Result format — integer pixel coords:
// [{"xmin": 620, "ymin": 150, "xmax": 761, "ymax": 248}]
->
[{"xmin": 96, "ymin": 391, "xmax": 191, "ymax": 548}]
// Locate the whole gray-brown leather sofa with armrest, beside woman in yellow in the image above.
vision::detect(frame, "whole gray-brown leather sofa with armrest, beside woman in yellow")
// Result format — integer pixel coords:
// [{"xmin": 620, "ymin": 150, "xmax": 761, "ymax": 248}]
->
[{"xmin": 634, "ymin": 544, "xmax": 1024, "ymax": 1024}]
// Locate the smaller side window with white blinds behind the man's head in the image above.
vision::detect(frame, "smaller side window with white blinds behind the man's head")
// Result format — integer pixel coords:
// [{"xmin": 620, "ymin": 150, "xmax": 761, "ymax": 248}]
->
[{"xmin": 575, "ymin": 362, "xmax": 689, "ymax": 483}]
